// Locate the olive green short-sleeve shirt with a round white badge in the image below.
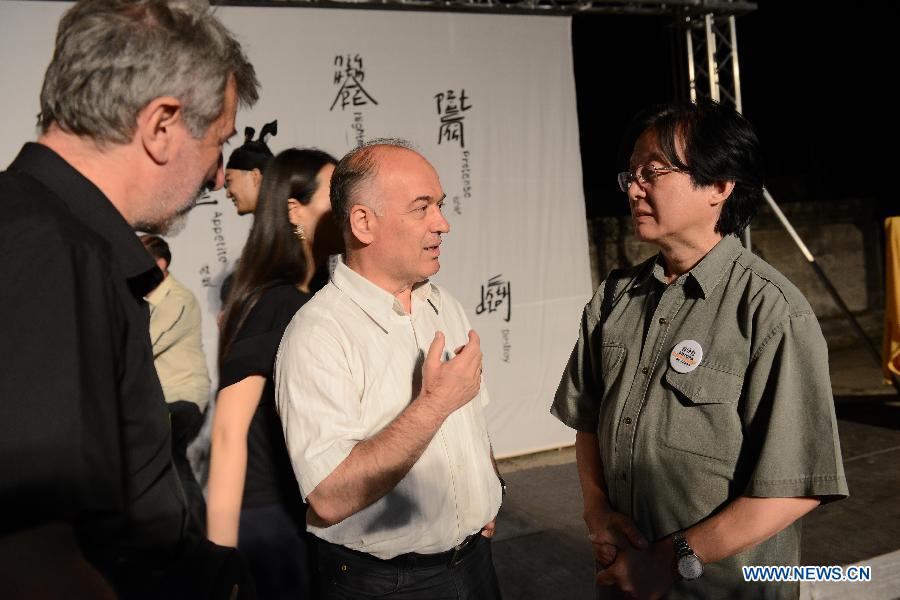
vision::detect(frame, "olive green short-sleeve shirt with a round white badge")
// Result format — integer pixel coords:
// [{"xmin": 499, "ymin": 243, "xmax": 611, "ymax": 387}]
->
[{"xmin": 551, "ymin": 236, "xmax": 848, "ymax": 599}]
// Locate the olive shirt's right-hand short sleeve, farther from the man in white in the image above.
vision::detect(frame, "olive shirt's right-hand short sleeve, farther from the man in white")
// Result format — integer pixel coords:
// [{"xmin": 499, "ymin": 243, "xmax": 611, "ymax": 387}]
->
[{"xmin": 742, "ymin": 312, "xmax": 848, "ymax": 501}]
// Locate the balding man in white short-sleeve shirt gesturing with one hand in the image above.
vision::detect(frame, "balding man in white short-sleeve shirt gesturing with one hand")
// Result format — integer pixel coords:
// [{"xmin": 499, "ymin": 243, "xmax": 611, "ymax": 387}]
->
[{"xmin": 276, "ymin": 140, "xmax": 501, "ymax": 600}]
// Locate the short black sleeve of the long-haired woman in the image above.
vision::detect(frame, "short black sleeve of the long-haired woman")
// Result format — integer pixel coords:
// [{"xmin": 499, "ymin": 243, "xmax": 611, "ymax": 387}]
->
[{"xmin": 219, "ymin": 286, "xmax": 307, "ymax": 390}]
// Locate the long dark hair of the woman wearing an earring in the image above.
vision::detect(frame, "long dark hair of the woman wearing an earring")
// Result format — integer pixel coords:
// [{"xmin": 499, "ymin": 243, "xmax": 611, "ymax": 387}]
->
[{"xmin": 219, "ymin": 148, "xmax": 336, "ymax": 361}]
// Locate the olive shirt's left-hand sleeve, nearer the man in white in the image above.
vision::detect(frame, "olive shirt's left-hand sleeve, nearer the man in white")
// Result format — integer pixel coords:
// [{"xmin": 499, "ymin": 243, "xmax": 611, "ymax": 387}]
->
[{"xmin": 550, "ymin": 285, "xmax": 605, "ymax": 432}]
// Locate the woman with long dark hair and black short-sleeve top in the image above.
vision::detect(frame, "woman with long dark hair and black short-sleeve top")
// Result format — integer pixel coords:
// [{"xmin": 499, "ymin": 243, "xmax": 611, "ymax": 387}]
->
[{"xmin": 207, "ymin": 149, "xmax": 336, "ymax": 599}]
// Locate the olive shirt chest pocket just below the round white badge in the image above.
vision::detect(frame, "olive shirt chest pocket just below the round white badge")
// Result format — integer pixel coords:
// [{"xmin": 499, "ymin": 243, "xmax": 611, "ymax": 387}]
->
[{"xmin": 662, "ymin": 364, "xmax": 744, "ymax": 464}]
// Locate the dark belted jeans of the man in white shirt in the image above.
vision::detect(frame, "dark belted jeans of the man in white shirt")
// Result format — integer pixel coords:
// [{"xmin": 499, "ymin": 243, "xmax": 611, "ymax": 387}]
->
[{"xmin": 316, "ymin": 535, "xmax": 500, "ymax": 600}]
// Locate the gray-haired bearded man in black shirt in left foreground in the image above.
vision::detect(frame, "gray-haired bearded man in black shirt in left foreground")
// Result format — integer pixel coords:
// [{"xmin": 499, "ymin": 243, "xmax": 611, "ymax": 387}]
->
[{"xmin": 0, "ymin": 0, "xmax": 259, "ymax": 598}]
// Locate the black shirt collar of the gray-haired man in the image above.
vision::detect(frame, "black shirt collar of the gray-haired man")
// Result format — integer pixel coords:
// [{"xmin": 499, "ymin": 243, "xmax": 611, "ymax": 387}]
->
[{"xmin": 9, "ymin": 142, "xmax": 162, "ymax": 297}]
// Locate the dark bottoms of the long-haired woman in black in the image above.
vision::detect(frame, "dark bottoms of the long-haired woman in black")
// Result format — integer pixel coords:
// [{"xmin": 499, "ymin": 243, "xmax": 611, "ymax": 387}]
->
[{"xmin": 238, "ymin": 504, "xmax": 314, "ymax": 600}]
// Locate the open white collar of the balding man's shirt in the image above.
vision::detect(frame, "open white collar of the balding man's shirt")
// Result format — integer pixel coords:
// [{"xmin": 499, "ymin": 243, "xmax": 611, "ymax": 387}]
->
[{"xmin": 331, "ymin": 255, "xmax": 441, "ymax": 331}]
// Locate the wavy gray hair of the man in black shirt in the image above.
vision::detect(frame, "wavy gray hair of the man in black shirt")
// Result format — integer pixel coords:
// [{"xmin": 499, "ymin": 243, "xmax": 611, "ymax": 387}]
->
[{"xmin": 38, "ymin": 0, "xmax": 259, "ymax": 143}]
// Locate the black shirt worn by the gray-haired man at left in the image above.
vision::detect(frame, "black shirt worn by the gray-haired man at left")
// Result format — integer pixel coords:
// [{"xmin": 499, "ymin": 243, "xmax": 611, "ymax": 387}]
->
[{"xmin": 0, "ymin": 144, "xmax": 187, "ymax": 585}]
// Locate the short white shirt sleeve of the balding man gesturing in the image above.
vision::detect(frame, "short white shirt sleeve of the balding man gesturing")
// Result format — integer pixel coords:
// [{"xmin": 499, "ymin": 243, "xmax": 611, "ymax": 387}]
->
[{"xmin": 275, "ymin": 314, "xmax": 366, "ymax": 500}]
